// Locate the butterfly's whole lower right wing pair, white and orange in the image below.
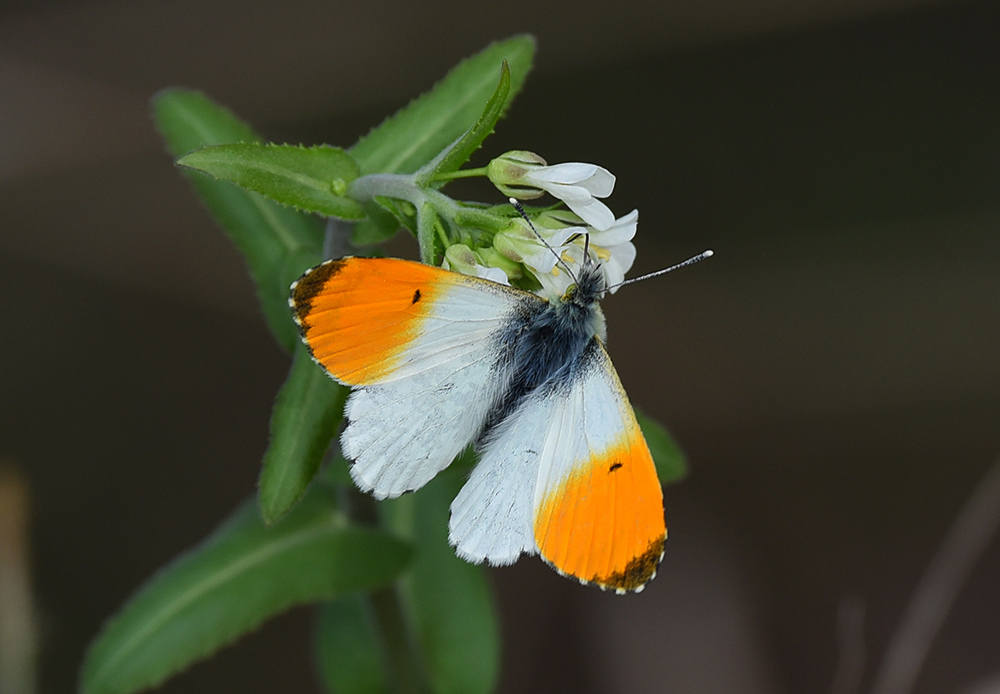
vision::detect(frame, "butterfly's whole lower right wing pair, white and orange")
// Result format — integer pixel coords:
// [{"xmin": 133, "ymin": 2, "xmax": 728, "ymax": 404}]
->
[{"xmin": 450, "ymin": 339, "xmax": 666, "ymax": 592}]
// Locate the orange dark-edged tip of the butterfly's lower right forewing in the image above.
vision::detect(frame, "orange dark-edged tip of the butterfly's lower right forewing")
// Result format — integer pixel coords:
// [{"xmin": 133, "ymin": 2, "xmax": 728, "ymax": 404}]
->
[{"xmin": 535, "ymin": 424, "xmax": 667, "ymax": 593}]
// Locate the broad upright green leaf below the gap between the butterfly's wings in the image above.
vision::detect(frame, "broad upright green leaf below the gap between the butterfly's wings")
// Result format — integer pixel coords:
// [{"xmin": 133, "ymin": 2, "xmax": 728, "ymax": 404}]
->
[{"xmin": 381, "ymin": 462, "xmax": 500, "ymax": 694}]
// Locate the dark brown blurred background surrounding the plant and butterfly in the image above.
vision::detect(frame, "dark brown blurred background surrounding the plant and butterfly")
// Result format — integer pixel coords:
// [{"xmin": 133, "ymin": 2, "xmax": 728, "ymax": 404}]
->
[{"xmin": 0, "ymin": 0, "xmax": 1000, "ymax": 694}]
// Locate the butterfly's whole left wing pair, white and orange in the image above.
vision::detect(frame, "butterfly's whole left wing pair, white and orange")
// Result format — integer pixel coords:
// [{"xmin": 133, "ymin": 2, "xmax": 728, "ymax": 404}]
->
[{"xmin": 291, "ymin": 258, "xmax": 541, "ymax": 498}]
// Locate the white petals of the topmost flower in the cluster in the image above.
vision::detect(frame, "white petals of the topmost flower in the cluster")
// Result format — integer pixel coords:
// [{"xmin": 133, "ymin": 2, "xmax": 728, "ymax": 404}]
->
[{"xmin": 519, "ymin": 162, "xmax": 615, "ymax": 231}]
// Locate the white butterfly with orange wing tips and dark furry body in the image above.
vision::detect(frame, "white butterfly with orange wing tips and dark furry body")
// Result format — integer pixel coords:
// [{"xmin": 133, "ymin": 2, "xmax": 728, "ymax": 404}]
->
[{"xmin": 289, "ymin": 250, "xmax": 666, "ymax": 593}]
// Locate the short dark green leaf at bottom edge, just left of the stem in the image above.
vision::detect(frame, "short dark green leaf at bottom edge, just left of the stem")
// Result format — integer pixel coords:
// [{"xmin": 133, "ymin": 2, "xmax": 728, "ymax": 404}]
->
[{"xmin": 316, "ymin": 595, "xmax": 389, "ymax": 694}]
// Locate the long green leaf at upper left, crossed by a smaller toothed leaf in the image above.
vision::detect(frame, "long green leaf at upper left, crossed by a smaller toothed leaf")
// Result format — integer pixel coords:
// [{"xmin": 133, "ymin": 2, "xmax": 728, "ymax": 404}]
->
[{"xmin": 153, "ymin": 89, "xmax": 323, "ymax": 352}]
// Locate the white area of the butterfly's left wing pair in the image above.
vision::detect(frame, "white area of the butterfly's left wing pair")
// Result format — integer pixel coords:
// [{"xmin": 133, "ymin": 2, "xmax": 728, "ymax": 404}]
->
[{"xmin": 341, "ymin": 278, "xmax": 527, "ymax": 499}]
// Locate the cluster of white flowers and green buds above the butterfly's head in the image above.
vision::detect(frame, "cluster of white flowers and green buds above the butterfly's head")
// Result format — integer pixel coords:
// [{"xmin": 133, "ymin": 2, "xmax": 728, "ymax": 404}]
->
[{"xmin": 444, "ymin": 151, "xmax": 639, "ymax": 300}]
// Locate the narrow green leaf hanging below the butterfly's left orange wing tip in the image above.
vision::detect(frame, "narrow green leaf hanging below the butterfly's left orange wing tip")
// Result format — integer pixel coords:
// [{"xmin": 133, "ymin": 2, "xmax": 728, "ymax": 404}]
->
[{"xmin": 257, "ymin": 345, "xmax": 348, "ymax": 524}]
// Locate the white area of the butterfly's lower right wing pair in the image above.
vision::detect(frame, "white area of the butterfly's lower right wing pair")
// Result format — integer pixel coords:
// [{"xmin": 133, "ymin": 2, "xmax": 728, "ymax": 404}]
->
[{"xmin": 449, "ymin": 340, "xmax": 627, "ymax": 564}]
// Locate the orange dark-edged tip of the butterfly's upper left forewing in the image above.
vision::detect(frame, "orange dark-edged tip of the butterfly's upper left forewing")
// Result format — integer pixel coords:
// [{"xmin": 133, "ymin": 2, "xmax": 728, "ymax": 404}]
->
[{"xmin": 291, "ymin": 258, "xmax": 455, "ymax": 385}]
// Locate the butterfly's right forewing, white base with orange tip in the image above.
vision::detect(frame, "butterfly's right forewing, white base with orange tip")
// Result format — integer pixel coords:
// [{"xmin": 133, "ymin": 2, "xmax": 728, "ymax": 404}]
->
[{"xmin": 533, "ymin": 340, "xmax": 666, "ymax": 592}]
